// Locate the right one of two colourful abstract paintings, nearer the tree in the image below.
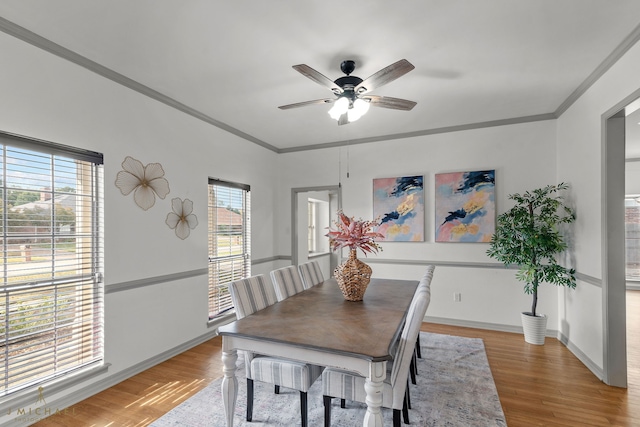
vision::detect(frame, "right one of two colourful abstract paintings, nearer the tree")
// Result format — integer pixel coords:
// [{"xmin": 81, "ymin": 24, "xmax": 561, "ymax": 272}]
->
[{"xmin": 435, "ymin": 170, "xmax": 496, "ymax": 242}]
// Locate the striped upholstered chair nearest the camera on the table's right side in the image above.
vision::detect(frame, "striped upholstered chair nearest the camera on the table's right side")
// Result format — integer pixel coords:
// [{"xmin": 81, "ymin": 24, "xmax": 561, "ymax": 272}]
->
[{"xmin": 322, "ymin": 266, "xmax": 434, "ymax": 427}]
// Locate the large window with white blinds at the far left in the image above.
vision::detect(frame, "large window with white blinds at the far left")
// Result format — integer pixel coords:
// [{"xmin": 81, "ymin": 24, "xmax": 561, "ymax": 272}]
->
[{"xmin": 0, "ymin": 133, "xmax": 104, "ymax": 396}]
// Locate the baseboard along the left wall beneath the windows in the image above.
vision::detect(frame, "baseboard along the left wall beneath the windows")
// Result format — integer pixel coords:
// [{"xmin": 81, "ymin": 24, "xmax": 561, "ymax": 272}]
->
[{"xmin": 0, "ymin": 329, "xmax": 218, "ymax": 427}]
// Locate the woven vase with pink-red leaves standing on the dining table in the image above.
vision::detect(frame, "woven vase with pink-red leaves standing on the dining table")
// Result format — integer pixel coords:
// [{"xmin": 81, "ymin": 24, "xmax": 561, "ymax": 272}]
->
[{"xmin": 326, "ymin": 211, "xmax": 384, "ymax": 301}]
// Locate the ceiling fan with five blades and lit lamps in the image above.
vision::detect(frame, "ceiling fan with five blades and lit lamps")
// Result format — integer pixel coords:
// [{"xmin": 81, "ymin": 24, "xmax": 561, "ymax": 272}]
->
[{"xmin": 278, "ymin": 59, "xmax": 416, "ymax": 125}]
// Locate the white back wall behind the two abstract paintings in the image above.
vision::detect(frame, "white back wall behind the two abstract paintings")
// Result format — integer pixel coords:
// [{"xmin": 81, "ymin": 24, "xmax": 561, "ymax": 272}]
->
[{"xmin": 278, "ymin": 121, "xmax": 558, "ymax": 328}]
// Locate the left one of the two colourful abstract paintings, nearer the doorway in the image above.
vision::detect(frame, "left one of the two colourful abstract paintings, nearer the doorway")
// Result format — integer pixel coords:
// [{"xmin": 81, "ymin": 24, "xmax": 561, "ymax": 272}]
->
[{"xmin": 373, "ymin": 176, "xmax": 424, "ymax": 242}]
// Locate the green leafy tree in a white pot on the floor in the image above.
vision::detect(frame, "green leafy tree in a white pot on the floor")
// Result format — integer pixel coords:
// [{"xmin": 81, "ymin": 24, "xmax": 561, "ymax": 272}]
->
[{"xmin": 487, "ymin": 183, "xmax": 576, "ymax": 345}]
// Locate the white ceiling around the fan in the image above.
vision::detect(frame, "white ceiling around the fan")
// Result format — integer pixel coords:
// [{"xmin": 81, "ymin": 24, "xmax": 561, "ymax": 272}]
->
[{"xmin": 0, "ymin": 0, "xmax": 640, "ymax": 152}]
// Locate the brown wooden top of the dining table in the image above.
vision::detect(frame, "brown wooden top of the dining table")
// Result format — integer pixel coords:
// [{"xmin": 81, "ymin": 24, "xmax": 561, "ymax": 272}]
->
[{"xmin": 219, "ymin": 279, "xmax": 418, "ymax": 362}]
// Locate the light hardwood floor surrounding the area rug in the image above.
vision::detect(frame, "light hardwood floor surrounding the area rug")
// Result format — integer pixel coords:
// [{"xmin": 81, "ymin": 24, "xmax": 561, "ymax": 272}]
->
[{"xmin": 35, "ymin": 291, "xmax": 640, "ymax": 427}]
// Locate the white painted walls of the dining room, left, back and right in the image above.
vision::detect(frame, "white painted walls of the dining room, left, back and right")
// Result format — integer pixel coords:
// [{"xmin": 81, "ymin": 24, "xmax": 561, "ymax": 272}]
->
[{"xmin": 0, "ymin": 14, "xmax": 640, "ymax": 424}]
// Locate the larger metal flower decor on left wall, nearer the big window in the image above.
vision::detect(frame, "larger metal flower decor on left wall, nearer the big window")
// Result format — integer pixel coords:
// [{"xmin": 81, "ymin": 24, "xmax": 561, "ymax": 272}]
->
[{"xmin": 116, "ymin": 156, "xmax": 169, "ymax": 211}]
